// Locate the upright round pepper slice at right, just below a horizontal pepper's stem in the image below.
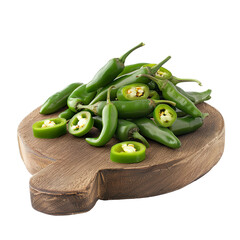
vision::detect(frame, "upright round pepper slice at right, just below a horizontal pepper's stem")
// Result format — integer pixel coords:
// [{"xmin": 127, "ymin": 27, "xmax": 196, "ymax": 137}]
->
[{"xmin": 153, "ymin": 104, "xmax": 177, "ymax": 127}]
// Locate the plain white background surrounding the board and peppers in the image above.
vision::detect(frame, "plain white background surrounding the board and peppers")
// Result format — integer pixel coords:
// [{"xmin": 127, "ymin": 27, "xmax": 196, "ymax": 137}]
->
[{"xmin": 0, "ymin": 0, "xmax": 240, "ymax": 240}]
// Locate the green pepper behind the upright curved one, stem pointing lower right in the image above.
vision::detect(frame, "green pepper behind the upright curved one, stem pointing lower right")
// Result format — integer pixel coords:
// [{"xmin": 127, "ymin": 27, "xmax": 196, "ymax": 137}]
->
[{"xmin": 93, "ymin": 116, "xmax": 149, "ymax": 148}]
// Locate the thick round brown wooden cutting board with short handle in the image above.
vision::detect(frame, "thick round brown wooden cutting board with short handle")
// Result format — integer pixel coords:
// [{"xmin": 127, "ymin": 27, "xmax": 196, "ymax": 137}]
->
[{"xmin": 18, "ymin": 103, "xmax": 225, "ymax": 215}]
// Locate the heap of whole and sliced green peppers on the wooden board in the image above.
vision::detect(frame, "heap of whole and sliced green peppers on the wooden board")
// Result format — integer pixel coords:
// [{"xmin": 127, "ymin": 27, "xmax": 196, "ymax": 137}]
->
[{"xmin": 34, "ymin": 43, "xmax": 211, "ymax": 163}]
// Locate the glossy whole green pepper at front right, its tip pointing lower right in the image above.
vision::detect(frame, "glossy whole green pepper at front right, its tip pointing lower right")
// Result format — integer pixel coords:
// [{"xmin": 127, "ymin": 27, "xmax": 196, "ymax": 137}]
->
[{"xmin": 133, "ymin": 118, "xmax": 181, "ymax": 148}]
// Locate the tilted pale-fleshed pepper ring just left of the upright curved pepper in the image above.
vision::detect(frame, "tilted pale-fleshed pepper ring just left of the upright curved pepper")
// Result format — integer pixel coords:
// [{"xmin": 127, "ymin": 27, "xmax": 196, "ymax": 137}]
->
[{"xmin": 68, "ymin": 111, "xmax": 93, "ymax": 137}]
